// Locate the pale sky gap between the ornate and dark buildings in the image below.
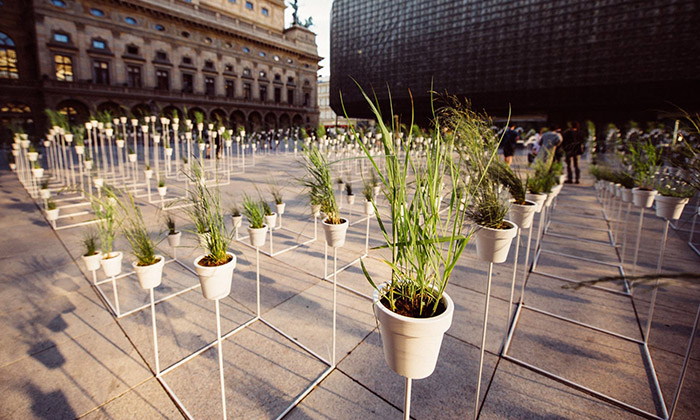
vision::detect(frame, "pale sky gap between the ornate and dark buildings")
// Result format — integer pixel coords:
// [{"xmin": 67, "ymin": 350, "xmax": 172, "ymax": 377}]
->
[{"xmin": 284, "ymin": 0, "xmax": 333, "ymax": 76}]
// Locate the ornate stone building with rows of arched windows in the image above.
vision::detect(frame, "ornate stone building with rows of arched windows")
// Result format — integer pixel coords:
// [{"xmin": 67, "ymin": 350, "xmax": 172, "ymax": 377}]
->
[{"xmin": 0, "ymin": 0, "xmax": 321, "ymax": 142}]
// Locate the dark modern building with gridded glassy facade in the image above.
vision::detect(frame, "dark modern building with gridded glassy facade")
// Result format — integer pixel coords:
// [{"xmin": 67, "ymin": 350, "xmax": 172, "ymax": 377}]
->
[{"xmin": 331, "ymin": 0, "xmax": 700, "ymax": 126}]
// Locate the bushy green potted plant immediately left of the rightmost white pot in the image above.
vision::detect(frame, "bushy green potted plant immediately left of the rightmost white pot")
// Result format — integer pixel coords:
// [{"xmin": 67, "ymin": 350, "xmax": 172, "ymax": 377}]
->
[{"xmin": 629, "ymin": 140, "xmax": 661, "ymax": 208}]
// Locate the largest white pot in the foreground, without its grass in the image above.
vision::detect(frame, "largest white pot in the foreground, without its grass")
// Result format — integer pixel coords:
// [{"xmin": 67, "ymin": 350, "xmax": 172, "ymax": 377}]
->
[{"xmin": 372, "ymin": 285, "xmax": 454, "ymax": 379}]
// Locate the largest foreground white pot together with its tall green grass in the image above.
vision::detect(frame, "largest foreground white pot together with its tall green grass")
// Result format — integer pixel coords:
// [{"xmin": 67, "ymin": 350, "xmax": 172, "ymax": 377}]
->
[{"xmin": 350, "ymin": 92, "xmax": 468, "ymax": 379}]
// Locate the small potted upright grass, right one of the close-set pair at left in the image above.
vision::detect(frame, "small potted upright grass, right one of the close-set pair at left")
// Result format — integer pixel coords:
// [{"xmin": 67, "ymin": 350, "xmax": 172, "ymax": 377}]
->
[{"xmin": 90, "ymin": 187, "xmax": 124, "ymax": 277}]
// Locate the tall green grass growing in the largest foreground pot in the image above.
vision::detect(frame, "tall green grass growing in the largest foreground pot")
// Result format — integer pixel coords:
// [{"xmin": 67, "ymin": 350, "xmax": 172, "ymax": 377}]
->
[{"xmin": 342, "ymin": 91, "xmax": 471, "ymax": 318}]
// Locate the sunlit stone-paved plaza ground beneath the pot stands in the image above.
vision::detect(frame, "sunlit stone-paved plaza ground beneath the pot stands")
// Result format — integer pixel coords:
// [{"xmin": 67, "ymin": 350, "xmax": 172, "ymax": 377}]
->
[{"xmin": 0, "ymin": 154, "xmax": 700, "ymax": 420}]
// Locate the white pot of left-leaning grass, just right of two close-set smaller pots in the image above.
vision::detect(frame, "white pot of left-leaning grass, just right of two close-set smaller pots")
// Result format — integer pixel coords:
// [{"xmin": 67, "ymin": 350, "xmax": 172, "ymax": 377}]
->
[{"xmin": 121, "ymin": 194, "xmax": 165, "ymax": 289}]
